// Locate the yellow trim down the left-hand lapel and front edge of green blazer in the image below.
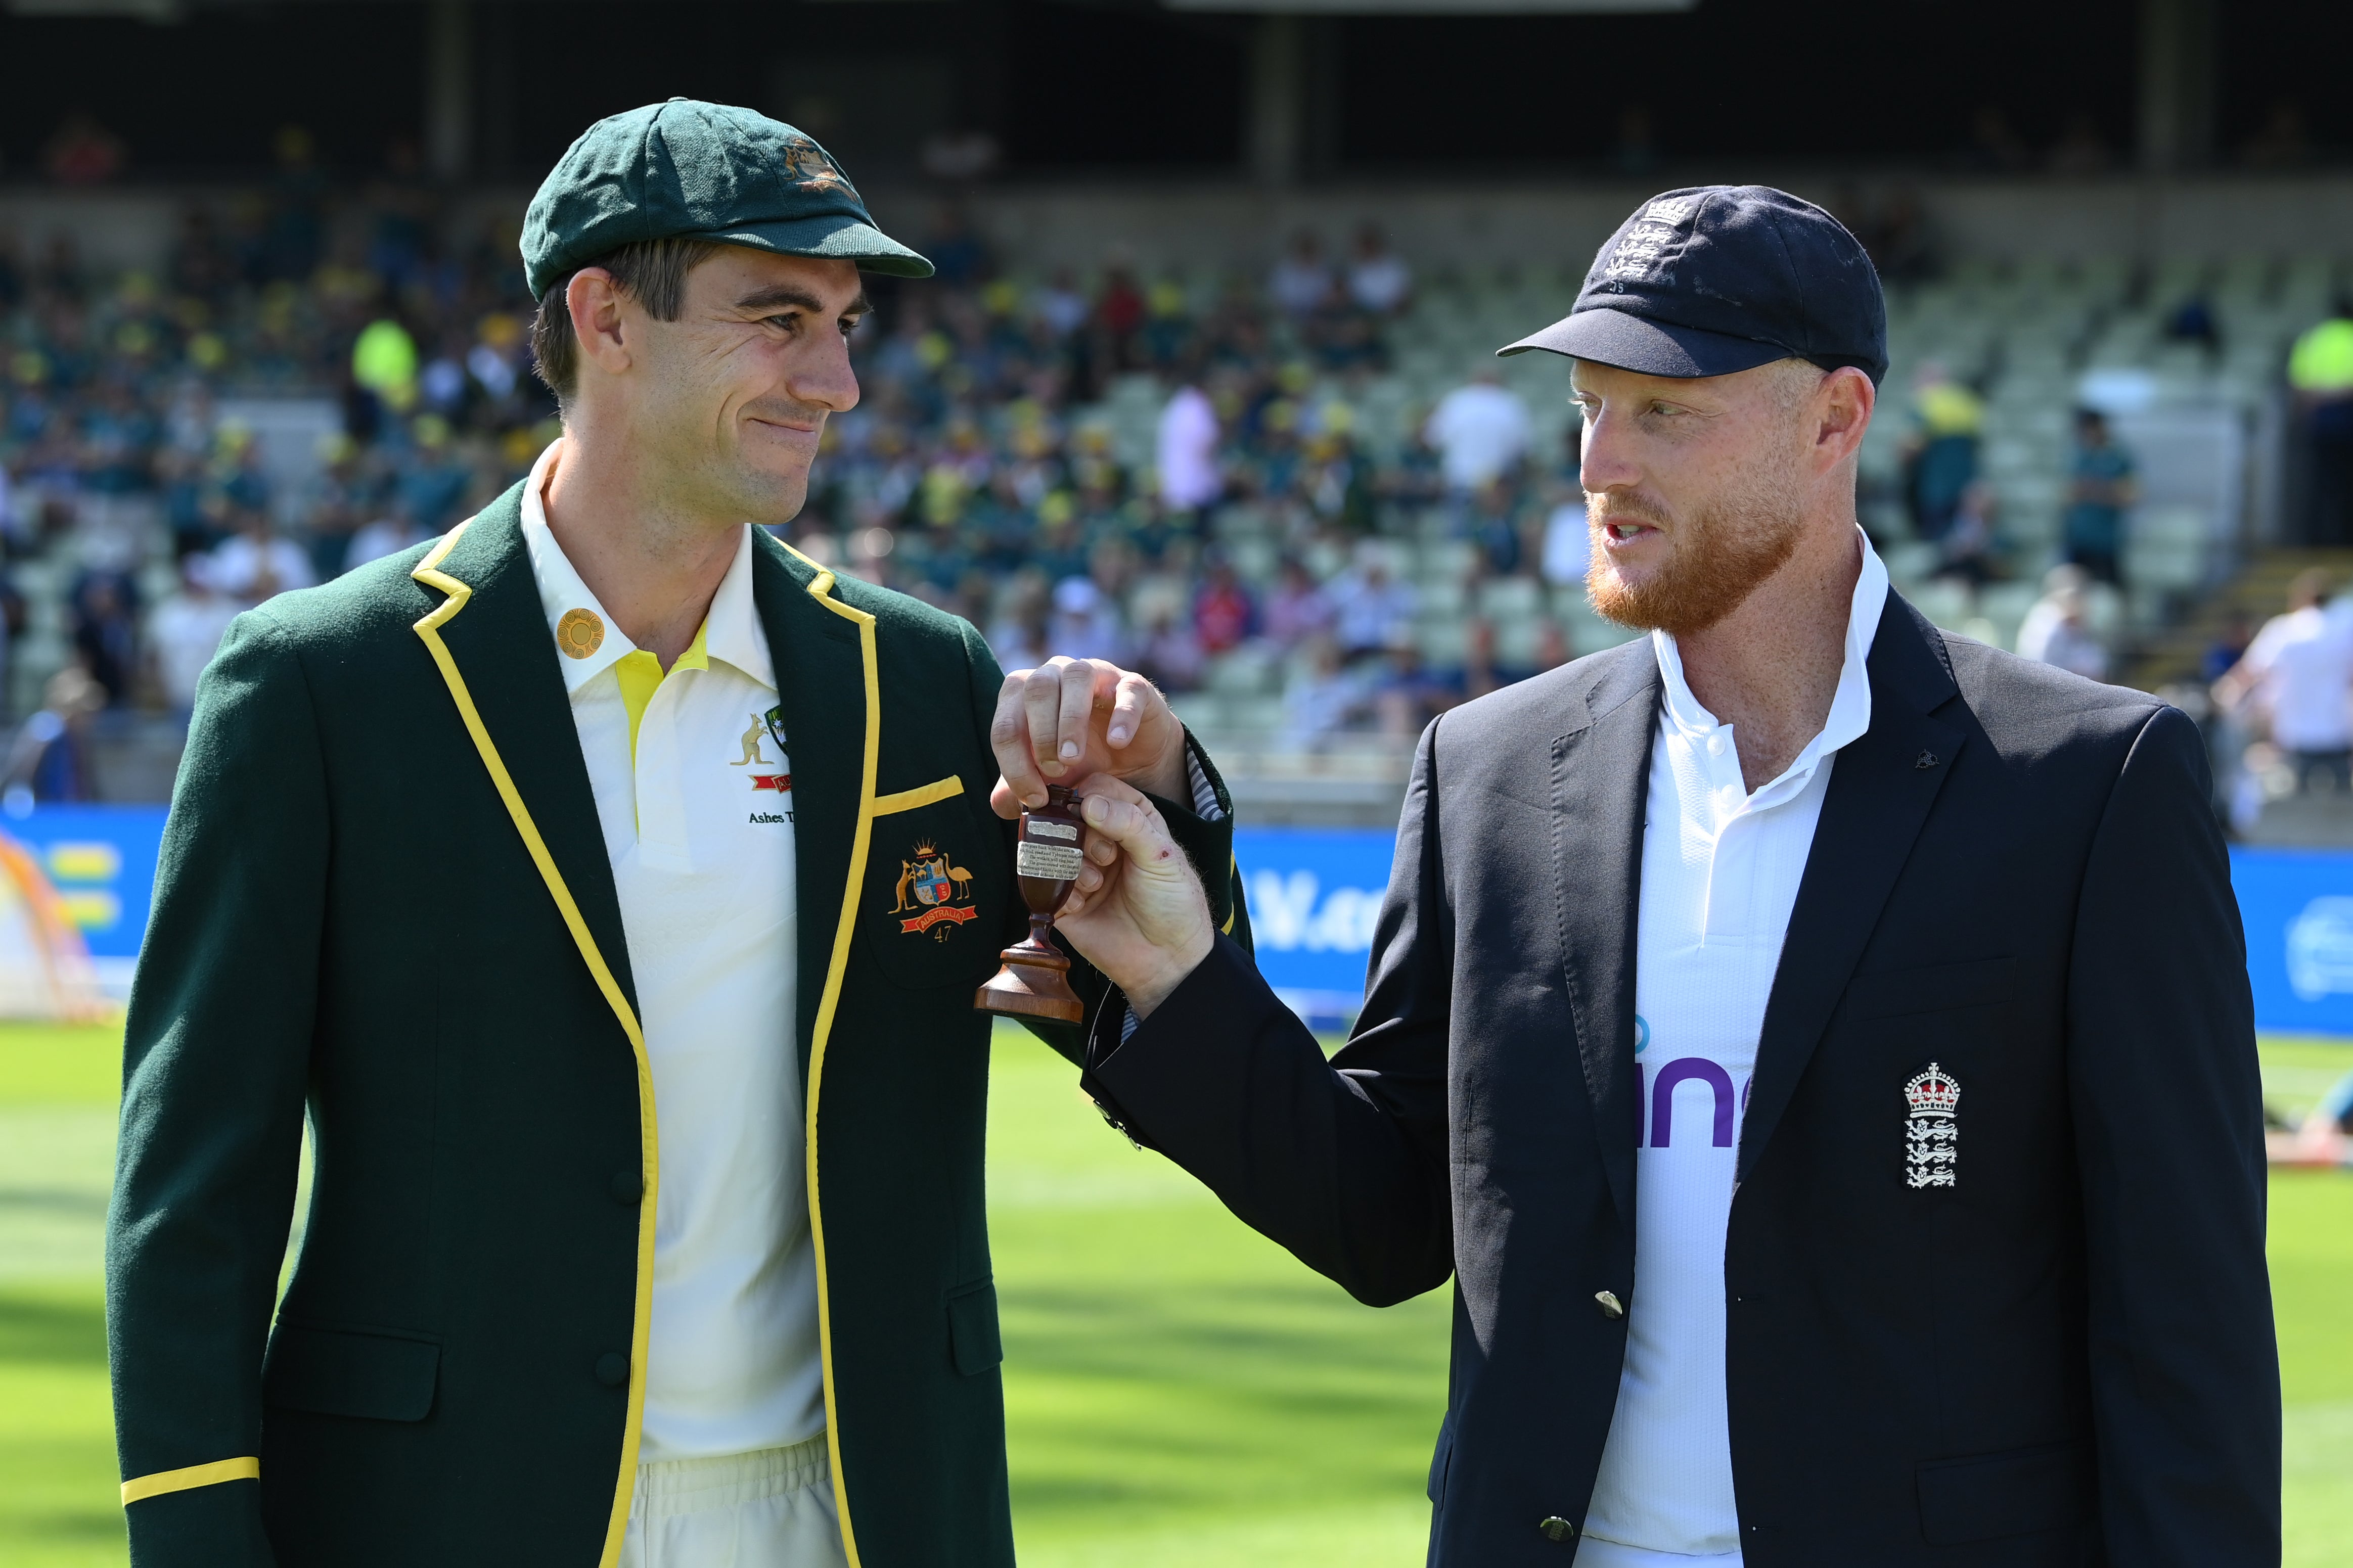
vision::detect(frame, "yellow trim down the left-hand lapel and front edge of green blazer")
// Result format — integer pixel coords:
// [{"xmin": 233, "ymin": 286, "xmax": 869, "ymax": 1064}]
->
[{"xmin": 410, "ymin": 517, "xmax": 659, "ymax": 1568}]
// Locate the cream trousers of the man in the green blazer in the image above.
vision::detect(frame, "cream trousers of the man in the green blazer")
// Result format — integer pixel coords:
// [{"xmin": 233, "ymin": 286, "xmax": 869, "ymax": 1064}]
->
[{"xmin": 621, "ymin": 1432, "xmax": 847, "ymax": 1568}]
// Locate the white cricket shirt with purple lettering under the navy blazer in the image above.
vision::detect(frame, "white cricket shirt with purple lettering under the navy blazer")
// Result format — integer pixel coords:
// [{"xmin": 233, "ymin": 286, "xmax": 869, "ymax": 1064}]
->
[{"xmin": 1576, "ymin": 531, "xmax": 1887, "ymax": 1568}]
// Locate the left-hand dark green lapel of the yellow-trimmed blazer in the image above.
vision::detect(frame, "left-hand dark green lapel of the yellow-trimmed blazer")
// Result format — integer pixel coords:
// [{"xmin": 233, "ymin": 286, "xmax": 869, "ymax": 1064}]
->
[{"xmin": 417, "ymin": 484, "xmax": 638, "ymax": 1011}]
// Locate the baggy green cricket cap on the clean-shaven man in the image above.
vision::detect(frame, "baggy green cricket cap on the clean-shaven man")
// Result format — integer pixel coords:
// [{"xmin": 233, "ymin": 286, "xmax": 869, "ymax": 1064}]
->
[{"xmin": 522, "ymin": 99, "xmax": 932, "ymax": 299}]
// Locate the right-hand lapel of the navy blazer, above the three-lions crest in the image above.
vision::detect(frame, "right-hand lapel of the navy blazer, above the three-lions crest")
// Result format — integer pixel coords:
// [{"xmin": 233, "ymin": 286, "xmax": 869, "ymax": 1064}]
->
[{"xmin": 1737, "ymin": 590, "xmax": 1965, "ymax": 1180}]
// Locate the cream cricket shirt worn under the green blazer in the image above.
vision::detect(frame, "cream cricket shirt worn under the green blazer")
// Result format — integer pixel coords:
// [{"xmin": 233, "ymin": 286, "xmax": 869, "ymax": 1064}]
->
[{"xmin": 522, "ymin": 442, "xmax": 826, "ymax": 1462}]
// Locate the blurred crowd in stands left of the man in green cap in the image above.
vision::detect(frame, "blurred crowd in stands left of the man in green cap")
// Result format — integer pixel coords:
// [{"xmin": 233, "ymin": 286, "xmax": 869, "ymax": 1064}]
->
[{"xmin": 0, "ymin": 131, "xmax": 553, "ymax": 761}]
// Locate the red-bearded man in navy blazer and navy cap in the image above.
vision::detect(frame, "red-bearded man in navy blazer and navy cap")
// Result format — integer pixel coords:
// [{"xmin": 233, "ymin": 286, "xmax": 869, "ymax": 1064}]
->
[{"xmin": 1040, "ymin": 186, "xmax": 2280, "ymax": 1568}]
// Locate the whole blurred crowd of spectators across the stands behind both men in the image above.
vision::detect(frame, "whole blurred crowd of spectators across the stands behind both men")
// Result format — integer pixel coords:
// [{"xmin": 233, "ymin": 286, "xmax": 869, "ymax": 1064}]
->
[{"xmin": 14, "ymin": 111, "xmax": 2353, "ymax": 799}]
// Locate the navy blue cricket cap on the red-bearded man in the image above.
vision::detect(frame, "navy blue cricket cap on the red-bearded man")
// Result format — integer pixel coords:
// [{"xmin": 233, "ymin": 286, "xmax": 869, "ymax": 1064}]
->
[{"xmin": 1497, "ymin": 186, "xmax": 1887, "ymax": 381}]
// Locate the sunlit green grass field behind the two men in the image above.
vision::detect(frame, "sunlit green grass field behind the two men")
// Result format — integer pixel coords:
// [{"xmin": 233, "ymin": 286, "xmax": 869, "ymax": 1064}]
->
[{"xmin": 0, "ymin": 1027, "xmax": 2353, "ymax": 1568}]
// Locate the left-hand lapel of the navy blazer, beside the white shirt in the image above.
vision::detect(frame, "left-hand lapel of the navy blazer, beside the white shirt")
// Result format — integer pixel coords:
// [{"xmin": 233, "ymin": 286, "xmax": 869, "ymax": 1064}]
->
[{"xmin": 1553, "ymin": 639, "xmax": 1659, "ymax": 1225}]
